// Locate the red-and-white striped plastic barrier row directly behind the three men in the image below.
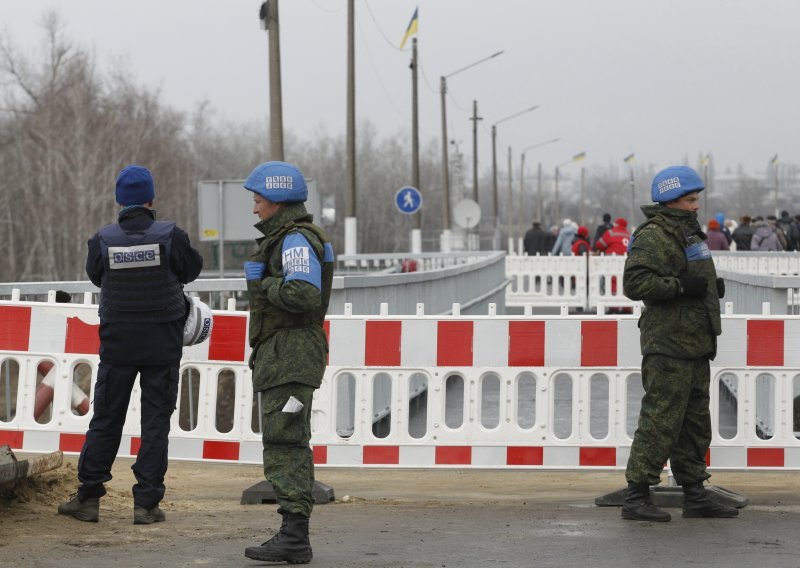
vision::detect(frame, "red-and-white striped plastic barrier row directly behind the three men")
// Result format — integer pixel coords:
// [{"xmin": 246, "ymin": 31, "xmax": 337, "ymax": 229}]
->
[{"xmin": 0, "ymin": 302, "xmax": 800, "ymax": 469}]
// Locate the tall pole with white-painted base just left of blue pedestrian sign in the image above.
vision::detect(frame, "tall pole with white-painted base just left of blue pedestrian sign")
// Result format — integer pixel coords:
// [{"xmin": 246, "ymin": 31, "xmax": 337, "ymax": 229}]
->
[{"xmin": 344, "ymin": 0, "xmax": 358, "ymax": 254}]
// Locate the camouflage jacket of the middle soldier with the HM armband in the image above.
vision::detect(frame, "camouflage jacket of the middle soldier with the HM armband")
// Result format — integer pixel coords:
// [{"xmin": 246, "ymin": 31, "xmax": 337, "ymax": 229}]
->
[{"xmin": 247, "ymin": 203, "xmax": 333, "ymax": 391}]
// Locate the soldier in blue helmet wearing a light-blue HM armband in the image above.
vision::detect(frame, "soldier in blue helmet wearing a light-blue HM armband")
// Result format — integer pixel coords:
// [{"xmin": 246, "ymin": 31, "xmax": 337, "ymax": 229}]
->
[{"xmin": 244, "ymin": 162, "xmax": 333, "ymax": 564}]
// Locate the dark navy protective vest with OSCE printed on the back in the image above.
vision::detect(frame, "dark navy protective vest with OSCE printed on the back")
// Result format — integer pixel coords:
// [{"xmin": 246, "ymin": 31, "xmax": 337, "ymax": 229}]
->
[{"xmin": 98, "ymin": 221, "xmax": 186, "ymax": 323}]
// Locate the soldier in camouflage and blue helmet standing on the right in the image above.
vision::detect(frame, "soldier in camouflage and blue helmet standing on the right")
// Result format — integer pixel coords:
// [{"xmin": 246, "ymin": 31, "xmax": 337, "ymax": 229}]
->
[{"xmin": 622, "ymin": 166, "xmax": 738, "ymax": 521}]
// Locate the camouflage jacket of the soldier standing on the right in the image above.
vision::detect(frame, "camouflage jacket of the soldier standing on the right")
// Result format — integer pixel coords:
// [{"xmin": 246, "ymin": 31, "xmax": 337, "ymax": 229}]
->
[{"xmin": 622, "ymin": 205, "xmax": 722, "ymax": 359}]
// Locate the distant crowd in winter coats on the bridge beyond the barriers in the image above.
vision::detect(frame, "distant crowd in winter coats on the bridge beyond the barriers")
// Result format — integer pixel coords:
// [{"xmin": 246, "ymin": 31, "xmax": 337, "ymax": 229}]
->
[{"xmin": 523, "ymin": 211, "xmax": 800, "ymax": 256}]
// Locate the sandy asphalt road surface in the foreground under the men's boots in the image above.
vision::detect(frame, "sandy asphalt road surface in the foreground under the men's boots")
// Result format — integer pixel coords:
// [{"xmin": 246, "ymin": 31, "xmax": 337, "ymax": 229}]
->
[{"xmin": 0, "ymin": 459, "xmax": 800, "ymax": 568}]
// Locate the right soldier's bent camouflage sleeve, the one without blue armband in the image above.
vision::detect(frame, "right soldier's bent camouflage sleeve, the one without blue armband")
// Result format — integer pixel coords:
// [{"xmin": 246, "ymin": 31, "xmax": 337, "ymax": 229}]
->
[{"xmin": 622, "ymin": 227, "xmax": 683, "ymax": 301}]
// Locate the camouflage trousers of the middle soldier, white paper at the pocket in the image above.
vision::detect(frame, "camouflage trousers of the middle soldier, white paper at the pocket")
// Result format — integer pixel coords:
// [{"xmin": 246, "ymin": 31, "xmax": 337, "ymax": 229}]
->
[{"xmin": 261, "ymin": 383, "xmax": 315, "ymax": 517}]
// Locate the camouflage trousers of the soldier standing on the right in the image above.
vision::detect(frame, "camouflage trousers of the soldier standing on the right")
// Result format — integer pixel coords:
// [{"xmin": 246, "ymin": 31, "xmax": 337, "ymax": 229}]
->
[{"xmin": 625, "ymin": 355, "xmax": 711, "ymax": 485}]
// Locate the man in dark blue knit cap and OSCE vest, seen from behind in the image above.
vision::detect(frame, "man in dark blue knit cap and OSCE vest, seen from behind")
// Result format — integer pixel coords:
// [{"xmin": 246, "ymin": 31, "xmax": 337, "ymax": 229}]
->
[{"xmin": 58, "ymin": 164, "xmax": 203, "ymax": 524}]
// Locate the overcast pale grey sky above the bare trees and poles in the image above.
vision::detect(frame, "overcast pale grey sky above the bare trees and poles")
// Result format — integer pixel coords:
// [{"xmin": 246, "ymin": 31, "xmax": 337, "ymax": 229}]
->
[{"xmin": 0, "ymin": 0, "xmax": 800, "ymax": 175}]
